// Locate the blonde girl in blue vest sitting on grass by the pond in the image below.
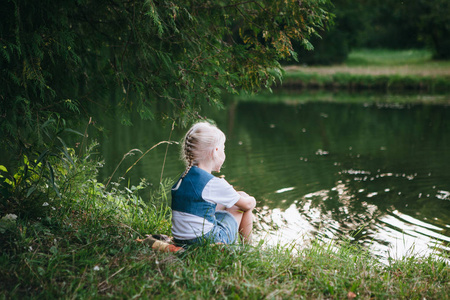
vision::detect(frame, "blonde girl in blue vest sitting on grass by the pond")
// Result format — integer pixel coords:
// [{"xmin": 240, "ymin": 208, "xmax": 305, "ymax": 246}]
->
[{"xmin": 172, "ymin": 122, "xmax": 256, "ymax": 246}]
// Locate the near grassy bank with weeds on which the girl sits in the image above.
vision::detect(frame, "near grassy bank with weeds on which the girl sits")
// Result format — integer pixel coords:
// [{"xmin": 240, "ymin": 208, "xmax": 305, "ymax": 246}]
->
[{"xmin": 0, "ymin": 151, "xmax": 450, "ymax": 299}]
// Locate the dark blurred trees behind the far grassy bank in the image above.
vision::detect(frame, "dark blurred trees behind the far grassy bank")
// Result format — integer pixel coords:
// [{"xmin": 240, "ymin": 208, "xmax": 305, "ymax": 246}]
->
[{"xmin": 294, "ymin": 0, "xmax": 450, "ymax": 64}]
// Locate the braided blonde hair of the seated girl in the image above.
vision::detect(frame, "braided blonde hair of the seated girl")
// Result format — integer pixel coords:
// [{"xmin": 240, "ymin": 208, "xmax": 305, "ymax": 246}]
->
[{"xmin": 181, "ymin": 122, "xmax": 225, "ymax": 177}]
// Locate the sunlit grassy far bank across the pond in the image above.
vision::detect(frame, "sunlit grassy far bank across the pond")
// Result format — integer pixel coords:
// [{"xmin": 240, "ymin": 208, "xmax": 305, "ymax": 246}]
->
[{"xmin": 280, "ymin": 50, "xmax": 450, "ymax": 93}]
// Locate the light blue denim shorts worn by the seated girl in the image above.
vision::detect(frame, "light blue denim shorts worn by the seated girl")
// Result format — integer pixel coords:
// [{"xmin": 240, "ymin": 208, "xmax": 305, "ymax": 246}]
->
[{"xmin": 174, "ymin": 210, "xmax": 238, "ymax": 246}]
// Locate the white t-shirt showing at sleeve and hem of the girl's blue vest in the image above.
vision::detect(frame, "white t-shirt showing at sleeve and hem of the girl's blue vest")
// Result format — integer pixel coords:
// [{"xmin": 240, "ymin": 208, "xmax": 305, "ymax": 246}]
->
[{"xmin": 172, "ymin": 177, "xmax": 241, "ymax": 240}]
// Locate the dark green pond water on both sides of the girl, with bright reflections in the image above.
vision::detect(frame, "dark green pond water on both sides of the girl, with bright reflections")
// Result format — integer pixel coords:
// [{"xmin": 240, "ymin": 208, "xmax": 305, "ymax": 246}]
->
[{"xmin": 92, "ymin": 94, "xmax": 450, "ymax": 258}]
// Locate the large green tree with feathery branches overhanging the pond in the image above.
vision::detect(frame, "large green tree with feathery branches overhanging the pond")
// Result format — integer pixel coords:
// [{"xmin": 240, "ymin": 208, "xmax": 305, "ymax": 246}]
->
[{"xmin": 0, "ymin": 0, "xmax": 330, "ymax": 150}]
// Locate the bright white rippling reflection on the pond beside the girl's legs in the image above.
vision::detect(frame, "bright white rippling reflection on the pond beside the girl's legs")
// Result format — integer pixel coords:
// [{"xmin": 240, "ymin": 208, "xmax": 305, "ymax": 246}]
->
[{"xmin": 255, "ymin": 183, "xmax": 450, "ymax": 259}]
